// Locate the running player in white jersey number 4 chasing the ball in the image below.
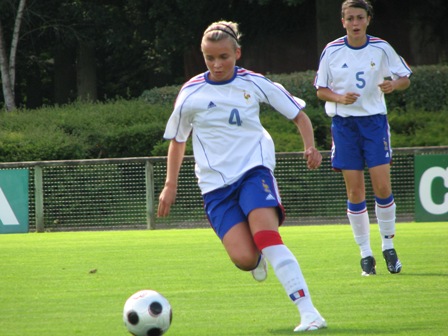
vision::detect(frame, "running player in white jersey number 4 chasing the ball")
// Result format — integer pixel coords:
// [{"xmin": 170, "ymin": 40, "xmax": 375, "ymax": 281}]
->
[{"xmin": 157, "ymin": 21, "xmax": 327, "ymax": 332}]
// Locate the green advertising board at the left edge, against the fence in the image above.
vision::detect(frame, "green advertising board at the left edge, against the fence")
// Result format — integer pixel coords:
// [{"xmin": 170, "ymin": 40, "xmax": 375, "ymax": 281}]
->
[{"xmin": 0, "ymin": 169, "xmax": 29, "ymax": 233}]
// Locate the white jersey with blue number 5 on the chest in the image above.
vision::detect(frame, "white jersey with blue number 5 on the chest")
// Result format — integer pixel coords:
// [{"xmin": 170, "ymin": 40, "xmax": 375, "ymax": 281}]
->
[{"xmin": 314, "ymin": 35, "xmax": 412, "ymax": 117}]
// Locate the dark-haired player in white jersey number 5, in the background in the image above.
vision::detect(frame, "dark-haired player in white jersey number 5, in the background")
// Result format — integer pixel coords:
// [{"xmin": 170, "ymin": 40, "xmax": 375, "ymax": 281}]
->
[{"xmin": 314, "ymin": 0, "xmax": 412, "ymax": 276}]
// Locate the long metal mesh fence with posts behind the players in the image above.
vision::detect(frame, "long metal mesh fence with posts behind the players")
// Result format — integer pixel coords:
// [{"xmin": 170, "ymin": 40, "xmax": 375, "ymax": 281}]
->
[{"xmin": 0, "ymin": 146, "xmax": 448, "ymax": 232}]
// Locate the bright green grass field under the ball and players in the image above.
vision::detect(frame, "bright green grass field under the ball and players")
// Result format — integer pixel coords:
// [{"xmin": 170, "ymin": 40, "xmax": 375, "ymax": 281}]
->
[{"xmin": 0, "ymin": 222, "xmax": 448, "ymax": 336}]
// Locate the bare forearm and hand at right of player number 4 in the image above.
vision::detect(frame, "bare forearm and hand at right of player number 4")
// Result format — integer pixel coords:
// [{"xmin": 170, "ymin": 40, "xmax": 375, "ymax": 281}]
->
[{"xmin": 293, "ymin": 110, "xmax": 322, "ymax": 169}]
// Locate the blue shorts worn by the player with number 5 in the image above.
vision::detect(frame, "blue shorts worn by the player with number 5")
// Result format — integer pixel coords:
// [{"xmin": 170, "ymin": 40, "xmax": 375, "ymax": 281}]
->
[{"xmin": 331, "ymin": 114, "xmax": 392, "ymax": 170}]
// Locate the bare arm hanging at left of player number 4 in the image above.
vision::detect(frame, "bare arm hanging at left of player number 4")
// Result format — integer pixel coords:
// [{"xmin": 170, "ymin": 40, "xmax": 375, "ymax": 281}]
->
[{"xmin": 157, "ymin": 139, "xmax": 186, "ymax": 217}]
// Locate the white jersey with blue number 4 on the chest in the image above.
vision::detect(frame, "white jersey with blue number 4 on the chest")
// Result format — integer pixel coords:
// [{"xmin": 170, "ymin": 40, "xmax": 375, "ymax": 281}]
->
[{"xmin": 163, "ymin": 67, "xmax": 304, "ymax": 194}]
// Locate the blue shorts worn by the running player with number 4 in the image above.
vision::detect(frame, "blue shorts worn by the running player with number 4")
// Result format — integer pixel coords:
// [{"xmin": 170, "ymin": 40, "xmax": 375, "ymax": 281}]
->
[{"xmin": 203, "ymin": 166, "xmax": 285, "ymax": 240}]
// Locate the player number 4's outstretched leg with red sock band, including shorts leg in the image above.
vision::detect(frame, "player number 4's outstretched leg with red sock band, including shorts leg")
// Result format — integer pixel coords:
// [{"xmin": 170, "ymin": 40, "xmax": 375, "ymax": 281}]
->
[{"xmin": 240, "ymin": 168, "xmax": 326, "ymax": 331}]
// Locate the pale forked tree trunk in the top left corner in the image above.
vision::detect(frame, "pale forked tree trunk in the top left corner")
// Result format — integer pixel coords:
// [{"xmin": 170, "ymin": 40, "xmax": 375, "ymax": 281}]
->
[{"xmin": 0, "ymin": 0, "xmax": 26, "ymax": 111}]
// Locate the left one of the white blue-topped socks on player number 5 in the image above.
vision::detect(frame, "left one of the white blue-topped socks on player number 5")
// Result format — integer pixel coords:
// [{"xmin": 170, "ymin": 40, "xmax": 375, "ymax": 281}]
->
[{"xmin": 347, "ymin": 201, "xmax": 373, "ymax": 258}]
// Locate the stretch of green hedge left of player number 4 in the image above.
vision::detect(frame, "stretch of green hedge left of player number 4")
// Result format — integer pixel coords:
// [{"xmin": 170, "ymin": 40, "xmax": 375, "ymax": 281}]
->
[{"xmin": 0, "ymin": 100, "xmax": 171, "ymax": 162}]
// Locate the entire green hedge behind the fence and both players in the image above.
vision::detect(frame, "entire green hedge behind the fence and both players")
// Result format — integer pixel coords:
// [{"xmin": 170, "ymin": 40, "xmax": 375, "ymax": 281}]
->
[{"xmin": 0, "ymin": 65, "xmax": 448, "ymax": 162}]
